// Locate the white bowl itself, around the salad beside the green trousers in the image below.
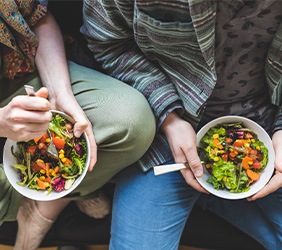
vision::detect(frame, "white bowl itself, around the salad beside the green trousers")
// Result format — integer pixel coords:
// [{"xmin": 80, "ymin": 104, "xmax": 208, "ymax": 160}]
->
[{"xmin": 3, "ymin": 110, "xmax": 90, "ymax": 201}]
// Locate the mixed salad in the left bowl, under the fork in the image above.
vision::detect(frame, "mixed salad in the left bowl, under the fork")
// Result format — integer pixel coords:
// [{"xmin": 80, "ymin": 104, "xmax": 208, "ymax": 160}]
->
[{"xmin": 11, "ymin": 114, "xmax": 87, "ymax": 193}]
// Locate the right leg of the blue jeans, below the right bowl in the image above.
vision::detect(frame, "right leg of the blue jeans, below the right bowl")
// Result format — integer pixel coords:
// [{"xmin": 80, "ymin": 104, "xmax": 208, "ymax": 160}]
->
[{"xmin": 199, "ymin": 189, "xmax": 282, "ymax": 250}]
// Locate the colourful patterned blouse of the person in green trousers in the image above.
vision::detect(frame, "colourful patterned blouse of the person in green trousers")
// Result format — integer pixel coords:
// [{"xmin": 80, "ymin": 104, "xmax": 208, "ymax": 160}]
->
[{"xmin": 0, "ymin": 0, "xmax": 47, "ymax": 80}]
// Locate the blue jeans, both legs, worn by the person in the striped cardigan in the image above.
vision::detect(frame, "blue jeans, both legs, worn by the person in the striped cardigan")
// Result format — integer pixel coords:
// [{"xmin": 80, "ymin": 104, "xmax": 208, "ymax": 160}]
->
[{"xmin": 110, "ymin": 167, "xmax": 282, "ymax": 250}]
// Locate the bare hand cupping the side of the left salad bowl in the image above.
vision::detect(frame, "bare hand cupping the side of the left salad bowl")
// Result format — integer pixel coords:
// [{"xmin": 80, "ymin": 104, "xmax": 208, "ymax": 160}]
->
[{"xmin": 49, "ymin": 92, "xmax": 97, "ymax": 171}]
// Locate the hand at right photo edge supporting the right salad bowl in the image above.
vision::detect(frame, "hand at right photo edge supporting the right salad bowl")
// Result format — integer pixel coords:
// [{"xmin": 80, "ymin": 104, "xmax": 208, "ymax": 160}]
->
[{"xmin": 248, "ymin": 130, "xmax": 282, "ymax": 201}]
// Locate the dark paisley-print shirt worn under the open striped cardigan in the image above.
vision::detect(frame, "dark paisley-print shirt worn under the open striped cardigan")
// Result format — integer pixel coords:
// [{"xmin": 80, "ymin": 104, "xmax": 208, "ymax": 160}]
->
[{"xmin": 199, "ymin": 0, "xmax": 282, "ymax": 133}]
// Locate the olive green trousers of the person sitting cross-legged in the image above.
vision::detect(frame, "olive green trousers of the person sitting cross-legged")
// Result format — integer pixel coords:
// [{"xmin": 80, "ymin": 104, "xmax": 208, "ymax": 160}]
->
[{"xmin": 0, "ymin": 62, "xmax": 155, "ymax": 224}]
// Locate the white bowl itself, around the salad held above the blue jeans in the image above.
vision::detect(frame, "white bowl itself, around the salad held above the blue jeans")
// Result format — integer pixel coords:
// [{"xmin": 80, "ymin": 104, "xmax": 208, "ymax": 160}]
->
[{"xmin": 197, "ymin": 116, "xmax": 275, "ymax": 200}]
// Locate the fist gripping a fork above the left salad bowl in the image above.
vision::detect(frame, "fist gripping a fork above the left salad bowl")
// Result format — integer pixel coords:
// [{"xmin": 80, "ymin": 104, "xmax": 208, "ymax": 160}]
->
[{"xmin": 0, "ymin": 87, "xmax": 52, "ymax": 141}]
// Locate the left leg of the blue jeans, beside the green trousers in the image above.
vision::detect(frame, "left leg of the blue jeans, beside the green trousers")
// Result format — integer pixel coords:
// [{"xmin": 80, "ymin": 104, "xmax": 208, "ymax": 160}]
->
[{"xmin": 110, "ymin": 167, "xmax": 200, "ymax": 250}]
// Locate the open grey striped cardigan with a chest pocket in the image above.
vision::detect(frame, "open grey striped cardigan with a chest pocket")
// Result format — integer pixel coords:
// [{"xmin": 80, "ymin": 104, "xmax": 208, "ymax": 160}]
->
[{"xmin": 81, "ymin": 0, "xmax": 282, "ymax": 171}]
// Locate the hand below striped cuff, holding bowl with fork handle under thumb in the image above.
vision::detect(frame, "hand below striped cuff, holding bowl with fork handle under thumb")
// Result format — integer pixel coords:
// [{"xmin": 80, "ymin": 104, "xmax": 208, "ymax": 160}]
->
[{"xmin": 161, "ymin": 112, "xmax": 207, "ymax": 193}]
